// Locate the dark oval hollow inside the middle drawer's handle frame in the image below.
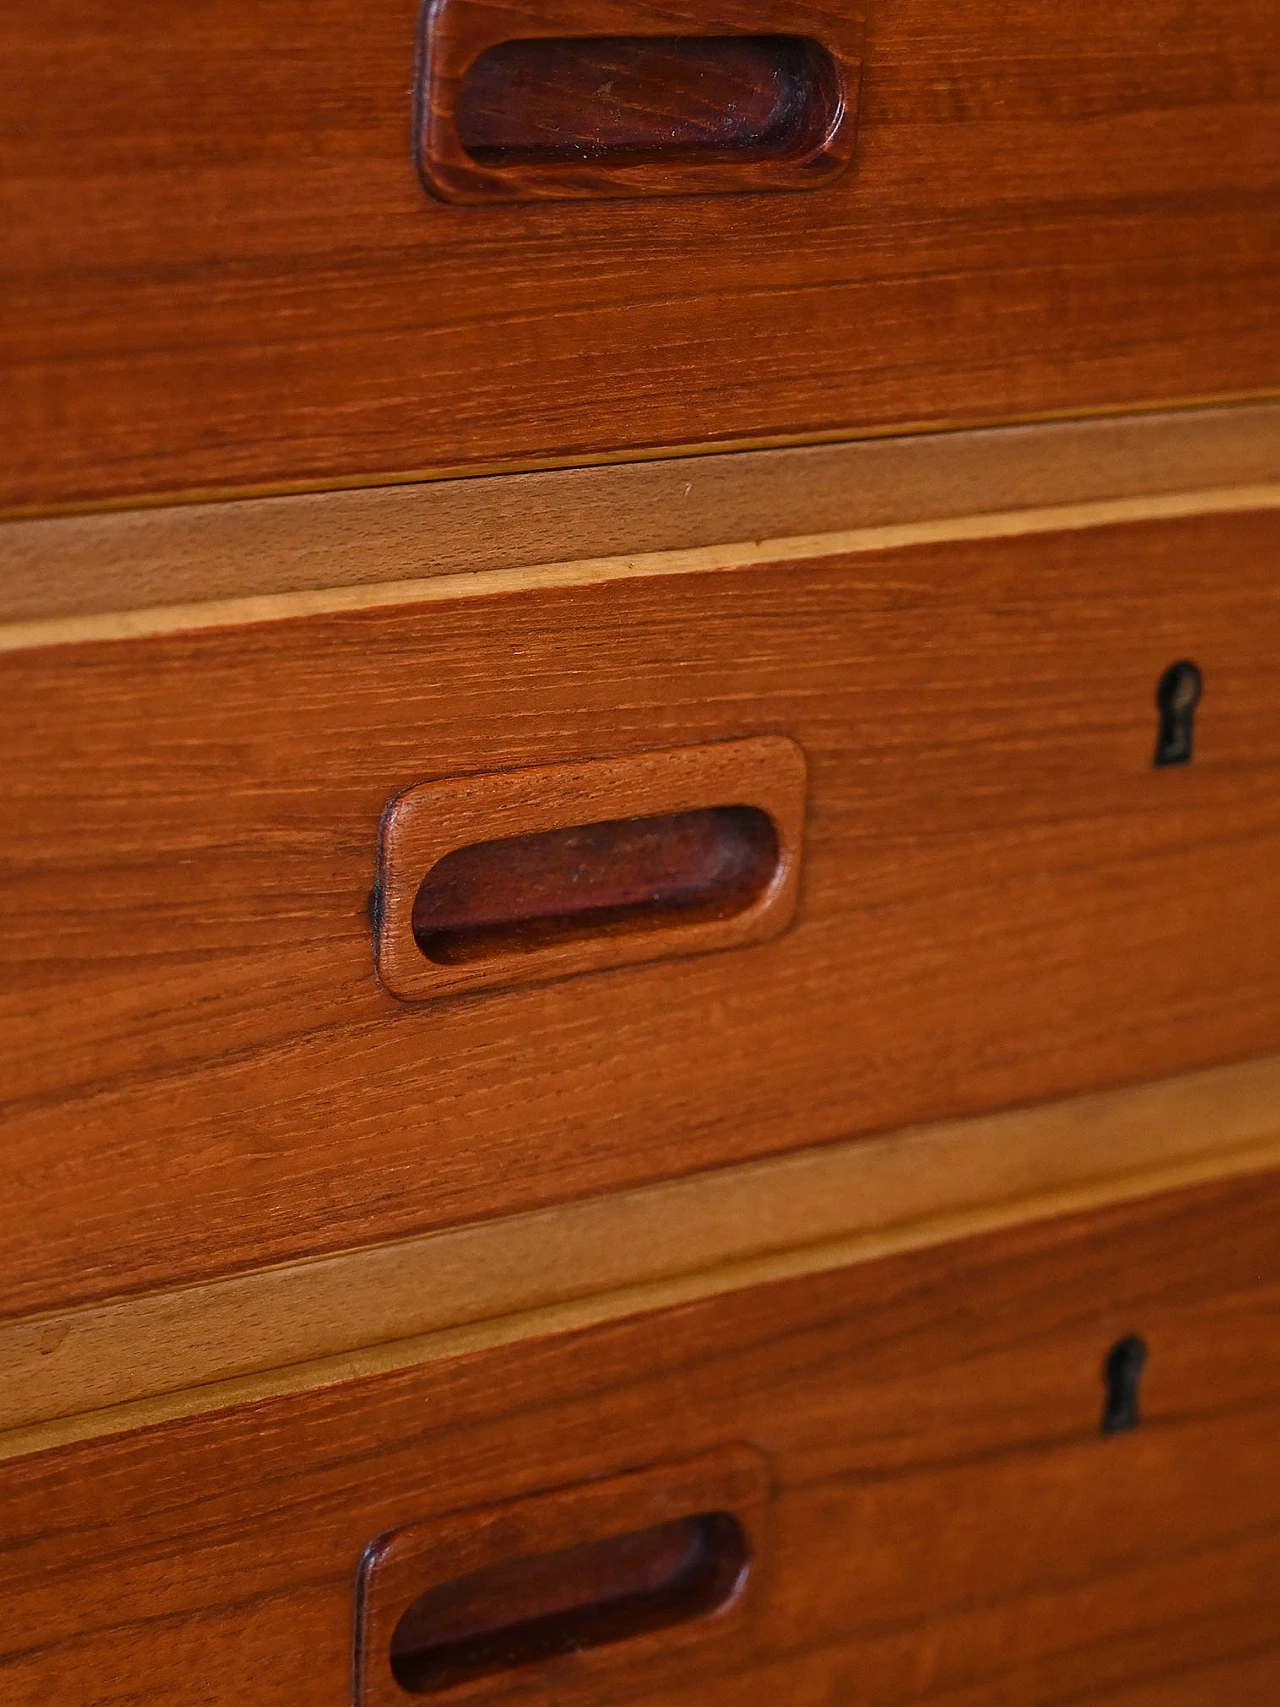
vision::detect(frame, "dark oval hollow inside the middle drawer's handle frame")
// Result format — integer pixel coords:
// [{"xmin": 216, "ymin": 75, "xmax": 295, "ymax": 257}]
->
[{"xmin": 413, "ymin": 806, "xmax": 780, "ymax": 966}]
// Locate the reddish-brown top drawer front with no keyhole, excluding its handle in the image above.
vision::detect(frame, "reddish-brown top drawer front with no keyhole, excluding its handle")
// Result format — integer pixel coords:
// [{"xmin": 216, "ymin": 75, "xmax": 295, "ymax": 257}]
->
[{"xmin": 0, "ymin": 0, "xmax": 1280, "ymax": 507}]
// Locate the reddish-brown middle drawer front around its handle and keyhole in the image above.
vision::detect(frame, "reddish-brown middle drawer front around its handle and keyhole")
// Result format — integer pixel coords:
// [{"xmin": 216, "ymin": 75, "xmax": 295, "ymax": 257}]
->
[{"xmin": 0, "ymin": 514, "xmax": 1280, "ymax": 1316}]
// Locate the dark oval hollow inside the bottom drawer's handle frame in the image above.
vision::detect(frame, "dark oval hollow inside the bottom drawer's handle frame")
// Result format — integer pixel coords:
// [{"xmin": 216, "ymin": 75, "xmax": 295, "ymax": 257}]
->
[{"xmin": 391, "ymin": 1512, "xmax": 748, "ymax": 1695}]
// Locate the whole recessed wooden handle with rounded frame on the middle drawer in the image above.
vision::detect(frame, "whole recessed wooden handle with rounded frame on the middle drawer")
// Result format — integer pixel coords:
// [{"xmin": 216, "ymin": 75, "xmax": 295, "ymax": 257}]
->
[{"xmin": 374, "ymin": 736, "xmax": 806, "ymax": 1002}]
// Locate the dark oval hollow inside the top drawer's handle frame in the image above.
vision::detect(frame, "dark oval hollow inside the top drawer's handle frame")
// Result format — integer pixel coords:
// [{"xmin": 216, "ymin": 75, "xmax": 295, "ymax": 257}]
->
[{"xmin": 454, "ymin": 36, "xmax": 841, "ymax": 166}]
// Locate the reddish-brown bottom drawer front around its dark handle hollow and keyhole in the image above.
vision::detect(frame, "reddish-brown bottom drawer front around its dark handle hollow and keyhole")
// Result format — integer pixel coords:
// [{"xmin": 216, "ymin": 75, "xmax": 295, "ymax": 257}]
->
[{"xmin": 0, "ymin": 1176, "xmax": 1280, "ymax": 1707}]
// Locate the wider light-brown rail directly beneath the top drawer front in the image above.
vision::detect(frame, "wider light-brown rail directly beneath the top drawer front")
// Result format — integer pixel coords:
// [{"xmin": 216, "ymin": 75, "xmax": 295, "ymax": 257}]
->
[{"xmin": 0, "ymin": 403, "xmax": 1280, "ymax": 625}]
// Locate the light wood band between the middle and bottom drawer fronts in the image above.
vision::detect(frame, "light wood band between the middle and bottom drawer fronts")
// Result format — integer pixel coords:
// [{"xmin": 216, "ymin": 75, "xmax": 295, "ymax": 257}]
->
[{"xmin": 0, "ymin": 1057, "xmax": 1280, "ymax": 1458}]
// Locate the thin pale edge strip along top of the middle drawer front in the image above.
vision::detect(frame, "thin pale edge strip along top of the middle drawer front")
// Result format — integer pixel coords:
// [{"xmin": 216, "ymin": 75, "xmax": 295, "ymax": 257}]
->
[{"xmin": 0, "ymin": 483, "xmax": 1280, "ymax": 652}]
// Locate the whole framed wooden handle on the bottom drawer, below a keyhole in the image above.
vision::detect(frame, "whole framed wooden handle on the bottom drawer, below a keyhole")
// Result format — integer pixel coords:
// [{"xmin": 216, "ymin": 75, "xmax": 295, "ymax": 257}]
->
[{"xmin": 352, "ymin": 1442, "xmax": 773, "ymax": 1707}]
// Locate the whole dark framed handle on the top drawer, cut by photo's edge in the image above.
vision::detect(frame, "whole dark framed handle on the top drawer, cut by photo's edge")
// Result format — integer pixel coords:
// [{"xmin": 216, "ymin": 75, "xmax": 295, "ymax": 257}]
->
[{"xmin": 418, "ymin": 0, "xmax": 862, "ymax": 201}]
